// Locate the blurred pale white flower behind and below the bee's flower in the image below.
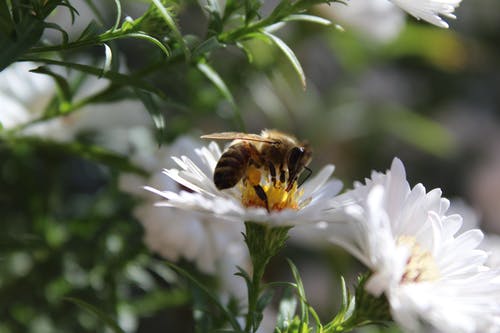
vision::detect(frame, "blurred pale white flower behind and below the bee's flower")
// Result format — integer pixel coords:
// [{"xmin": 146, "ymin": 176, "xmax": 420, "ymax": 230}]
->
[{"xmin": 120, "ymin": 137, "xmax": 250, "ymax": 300}]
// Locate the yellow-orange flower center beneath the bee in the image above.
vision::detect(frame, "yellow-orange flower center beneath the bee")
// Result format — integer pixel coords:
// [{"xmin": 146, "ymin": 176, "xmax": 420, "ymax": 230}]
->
[{"xmin": 239, "ymin": 167, "xmax": 303, "ymax": 211}]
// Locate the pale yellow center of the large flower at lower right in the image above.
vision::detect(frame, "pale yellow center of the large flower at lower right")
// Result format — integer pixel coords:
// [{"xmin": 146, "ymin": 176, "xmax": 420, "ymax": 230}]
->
[{"xmin": 397, "ymin": 236, "xmax": 440, "ymax": 284}]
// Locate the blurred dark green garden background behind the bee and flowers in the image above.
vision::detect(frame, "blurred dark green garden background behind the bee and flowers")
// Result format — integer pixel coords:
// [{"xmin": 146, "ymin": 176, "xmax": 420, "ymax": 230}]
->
[{"xmin": 0, "ymin": 0, "xmax": 500, "ymax": 333}]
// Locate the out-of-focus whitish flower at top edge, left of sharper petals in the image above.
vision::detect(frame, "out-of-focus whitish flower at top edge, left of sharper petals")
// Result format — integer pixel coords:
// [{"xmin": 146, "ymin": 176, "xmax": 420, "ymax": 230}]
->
[{"xmin": 318, "ymin": 0, "xmax": 405, "ymax": 43}]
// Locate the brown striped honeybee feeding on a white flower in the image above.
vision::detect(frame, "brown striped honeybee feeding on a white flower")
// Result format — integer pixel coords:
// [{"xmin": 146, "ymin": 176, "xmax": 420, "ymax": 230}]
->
[{"xmin": 201, "ymin": 130, "xmax": 312, "ymax": 208}]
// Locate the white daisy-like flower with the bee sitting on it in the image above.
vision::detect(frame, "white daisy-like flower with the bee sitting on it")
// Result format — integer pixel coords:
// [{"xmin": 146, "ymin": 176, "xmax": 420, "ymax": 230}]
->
[{"xmin": 146, "ymin": 142, "xmax": 341, "ymax": 226}]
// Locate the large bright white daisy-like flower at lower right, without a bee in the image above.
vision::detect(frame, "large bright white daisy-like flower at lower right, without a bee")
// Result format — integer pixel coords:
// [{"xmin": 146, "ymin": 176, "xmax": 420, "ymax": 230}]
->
[{"xmin": 323, "ymin": 159, "xmax": 500, "ymax": 332}]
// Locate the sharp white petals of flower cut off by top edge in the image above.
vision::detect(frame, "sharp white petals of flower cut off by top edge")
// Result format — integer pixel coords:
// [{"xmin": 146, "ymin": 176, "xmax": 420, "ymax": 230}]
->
[{"xmin": 391, "ymin": 0, "xmax": 462, "ymax": 28}]
